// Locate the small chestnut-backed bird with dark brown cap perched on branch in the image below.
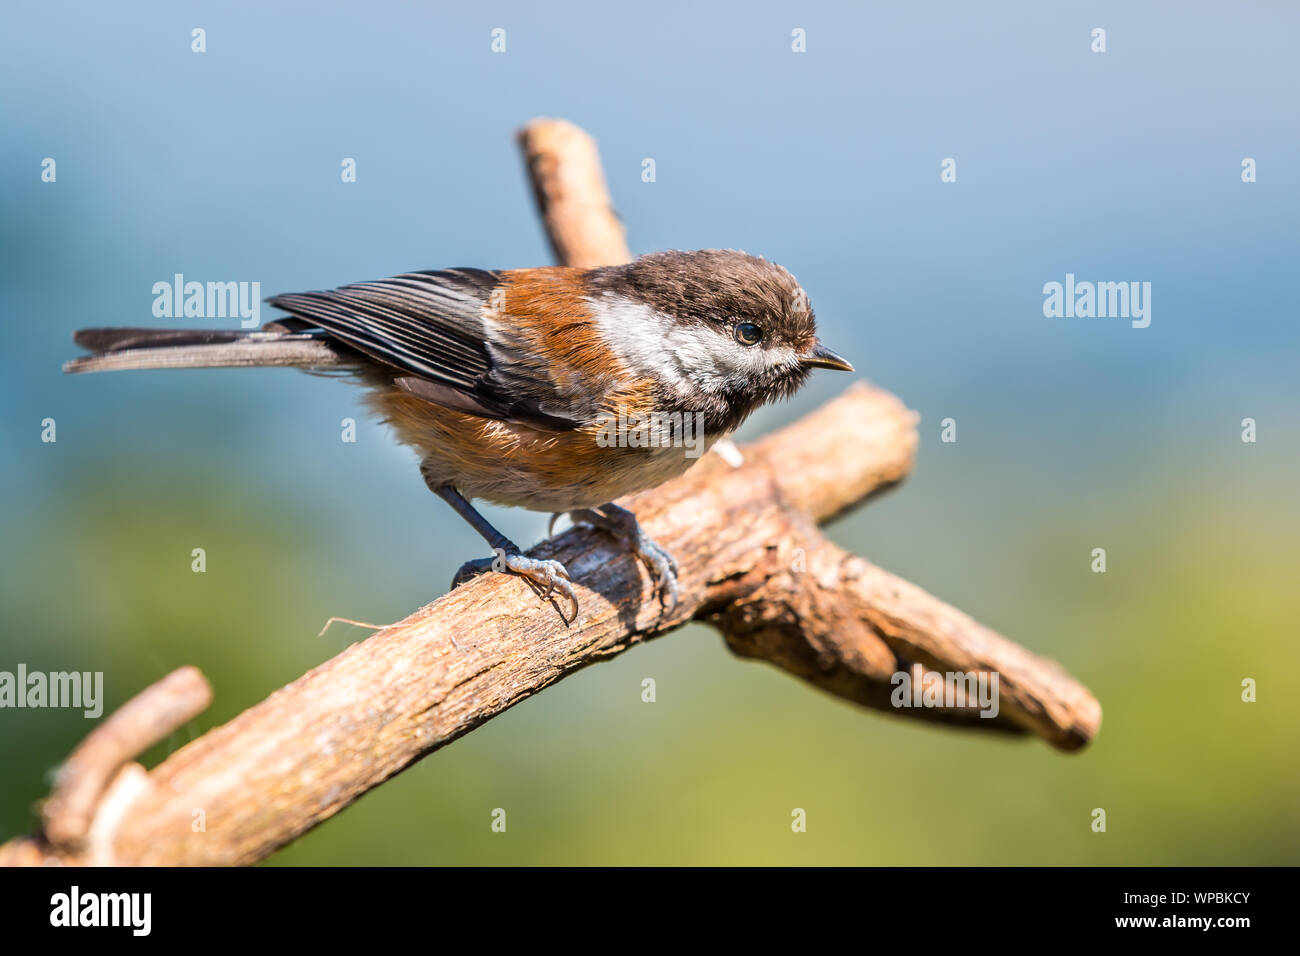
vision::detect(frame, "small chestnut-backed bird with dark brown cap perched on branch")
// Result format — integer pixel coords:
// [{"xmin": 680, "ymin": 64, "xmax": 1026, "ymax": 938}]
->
[{"xmin": 64, "ymin": 250, "xmax": 853, "ymax": 620}]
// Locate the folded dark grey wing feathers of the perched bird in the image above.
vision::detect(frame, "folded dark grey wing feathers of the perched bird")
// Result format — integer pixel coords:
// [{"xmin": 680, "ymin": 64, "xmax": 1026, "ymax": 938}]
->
[{"xmin": 268, "ymin": 269, "xmax": 581, "ymax": 431}]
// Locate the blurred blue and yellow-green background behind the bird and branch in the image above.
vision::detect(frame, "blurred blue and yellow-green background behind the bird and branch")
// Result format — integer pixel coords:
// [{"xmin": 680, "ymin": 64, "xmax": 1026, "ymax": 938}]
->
[{"xmin": 0, "ymin": 1, "xmax": 1300, "ymax": 864}]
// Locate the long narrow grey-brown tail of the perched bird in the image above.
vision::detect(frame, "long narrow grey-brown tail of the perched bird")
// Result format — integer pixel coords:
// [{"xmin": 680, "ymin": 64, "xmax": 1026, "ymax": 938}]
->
[{"xmin": 64, "ymin": 324, "xmax": 356, "ymax": 373}]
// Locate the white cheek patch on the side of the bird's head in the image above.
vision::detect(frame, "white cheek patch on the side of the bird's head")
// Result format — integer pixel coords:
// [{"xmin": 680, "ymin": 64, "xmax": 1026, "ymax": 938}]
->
[{"xmin": 588, "ymin": 293, "xmax": 798, "ymax": 395}]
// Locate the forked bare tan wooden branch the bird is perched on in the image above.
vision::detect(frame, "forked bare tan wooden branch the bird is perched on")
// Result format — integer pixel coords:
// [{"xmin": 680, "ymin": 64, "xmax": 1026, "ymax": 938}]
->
[{"xmin": 0, "ymin": 117, "xmax": 1101, "ymax": 865}]
